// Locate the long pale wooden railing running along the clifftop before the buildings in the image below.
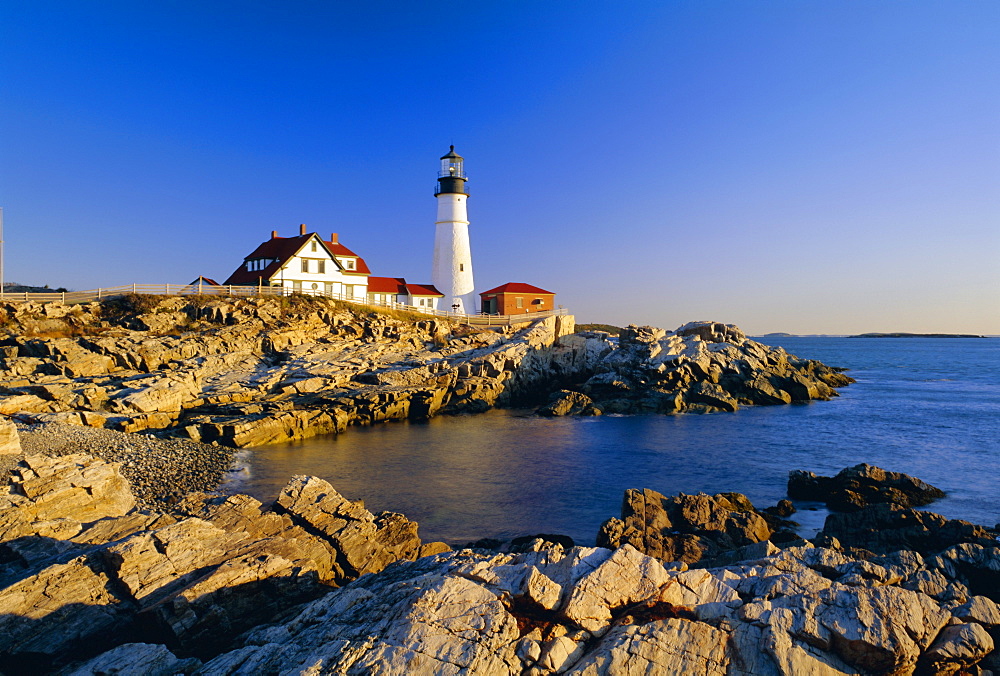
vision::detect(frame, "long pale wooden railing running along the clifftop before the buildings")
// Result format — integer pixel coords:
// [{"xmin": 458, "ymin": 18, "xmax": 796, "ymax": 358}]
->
[{"xmin": 0, "ymin": 284, "xmax": 569, "ymax": 326}]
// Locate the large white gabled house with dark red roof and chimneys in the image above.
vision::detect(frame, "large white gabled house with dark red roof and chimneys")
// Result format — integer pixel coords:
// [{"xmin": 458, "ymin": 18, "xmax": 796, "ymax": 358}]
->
[{"xmin": 222, "ymin": 225, "xmax": 371, "ymax": 301}]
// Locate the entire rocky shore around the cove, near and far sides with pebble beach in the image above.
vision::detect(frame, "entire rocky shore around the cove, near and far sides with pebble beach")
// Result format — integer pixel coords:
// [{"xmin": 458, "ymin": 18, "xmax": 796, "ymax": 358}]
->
[{"xmin": 15, "ymin": 297, "xmax": 972, "ymax": 676}]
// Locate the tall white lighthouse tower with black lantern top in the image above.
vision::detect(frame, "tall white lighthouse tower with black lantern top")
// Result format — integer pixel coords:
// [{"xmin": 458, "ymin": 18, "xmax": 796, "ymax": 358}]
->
[{"xmin": 431, "ymin": 146, "xmax": 476, "ymax": 314}]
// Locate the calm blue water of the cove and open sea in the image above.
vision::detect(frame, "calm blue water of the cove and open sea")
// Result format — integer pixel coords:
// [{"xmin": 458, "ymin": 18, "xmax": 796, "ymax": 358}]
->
[{"xmin": 229, "ymin": 338, "xmax": 1000, "ymax": 544}]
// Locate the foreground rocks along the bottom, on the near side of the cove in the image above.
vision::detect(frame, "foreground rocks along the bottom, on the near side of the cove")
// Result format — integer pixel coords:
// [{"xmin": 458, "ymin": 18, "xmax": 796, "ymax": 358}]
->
[{"xmin": 0, "ymin": 428, "xmax": 1000, "ymax": 676}]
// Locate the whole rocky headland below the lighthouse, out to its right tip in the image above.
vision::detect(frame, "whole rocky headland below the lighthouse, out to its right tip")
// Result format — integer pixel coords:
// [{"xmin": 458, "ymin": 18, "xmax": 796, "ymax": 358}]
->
[{"xmin": 0, "ymin": 296, "xmax": 853, "ymax": 448}]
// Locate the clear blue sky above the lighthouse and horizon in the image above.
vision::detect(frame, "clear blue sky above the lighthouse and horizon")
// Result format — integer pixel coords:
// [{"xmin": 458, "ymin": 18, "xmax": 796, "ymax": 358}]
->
[{"xmin": 0, "ymin": 0, "xmax": 1000, "ymax": 334}]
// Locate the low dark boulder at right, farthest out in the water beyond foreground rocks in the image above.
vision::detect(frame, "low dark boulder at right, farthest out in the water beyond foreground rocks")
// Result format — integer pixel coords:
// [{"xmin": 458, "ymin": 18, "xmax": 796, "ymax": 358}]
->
[{"xmin": 788, "ymin": 463, "xmax": 945, "ymax": 512}]
